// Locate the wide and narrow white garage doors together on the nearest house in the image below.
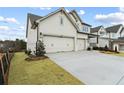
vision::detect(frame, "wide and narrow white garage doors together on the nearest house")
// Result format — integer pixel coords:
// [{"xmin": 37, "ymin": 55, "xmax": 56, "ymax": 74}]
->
[{"xmin": 43, "ymin": 35, "xmax": 87, "ymax": 53}]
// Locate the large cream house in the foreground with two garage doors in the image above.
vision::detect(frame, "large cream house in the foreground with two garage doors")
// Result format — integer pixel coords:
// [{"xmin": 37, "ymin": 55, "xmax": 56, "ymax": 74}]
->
[{"xmin": 26, "ymin": 8, "xmax": 95, "ymax": 53}]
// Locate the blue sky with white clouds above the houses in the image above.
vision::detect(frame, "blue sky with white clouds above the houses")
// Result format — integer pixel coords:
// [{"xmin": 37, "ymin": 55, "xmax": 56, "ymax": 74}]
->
[{"xmin": 0, "ymin": 7, "xmax": 124, "ymax": 40}]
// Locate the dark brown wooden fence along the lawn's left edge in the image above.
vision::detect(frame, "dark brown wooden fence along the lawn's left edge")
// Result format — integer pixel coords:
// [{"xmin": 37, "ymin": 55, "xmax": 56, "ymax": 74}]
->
[{"xmin": 0, "ymin": 52, "xmax": 14, "ymax": 85}]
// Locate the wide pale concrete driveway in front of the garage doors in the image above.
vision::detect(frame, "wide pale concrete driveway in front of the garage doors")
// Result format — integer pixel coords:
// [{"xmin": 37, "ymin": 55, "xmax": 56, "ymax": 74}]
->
[{"xmin": 47, "ymin": 51, "xmax": 124, "ymax": 85}]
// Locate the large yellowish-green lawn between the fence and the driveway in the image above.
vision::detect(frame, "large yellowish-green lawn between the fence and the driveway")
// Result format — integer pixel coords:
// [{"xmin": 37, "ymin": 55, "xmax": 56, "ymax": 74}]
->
[{"xmin": 8, "ymin": 52, "xmax": 83, "ymax": 85}]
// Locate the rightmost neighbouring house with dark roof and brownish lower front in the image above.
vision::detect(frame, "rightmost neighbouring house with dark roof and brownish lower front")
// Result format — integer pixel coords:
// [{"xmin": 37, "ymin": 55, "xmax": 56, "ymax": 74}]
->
[{"xmin": 106, "ymin": 24, "xmax": 124, "ymax": 51}]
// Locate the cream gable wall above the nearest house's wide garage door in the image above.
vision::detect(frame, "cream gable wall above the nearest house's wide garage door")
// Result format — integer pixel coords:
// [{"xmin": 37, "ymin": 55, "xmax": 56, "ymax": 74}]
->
[{"xmin": 39, "ymin": 12, "xmax": 76, "ymax": 37}]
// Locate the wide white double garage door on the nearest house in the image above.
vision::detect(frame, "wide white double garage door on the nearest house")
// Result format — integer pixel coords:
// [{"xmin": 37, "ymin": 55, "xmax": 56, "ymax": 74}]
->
[{"xmin": 43, "ymin": 36, "xmax": 74, "ymax": 53}]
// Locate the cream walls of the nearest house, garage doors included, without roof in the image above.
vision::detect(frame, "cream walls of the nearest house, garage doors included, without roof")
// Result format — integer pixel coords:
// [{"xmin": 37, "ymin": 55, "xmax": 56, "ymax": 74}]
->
[{"xmin": 27, "ymin": 12, "xmax": 89, "ymax": 53}]
